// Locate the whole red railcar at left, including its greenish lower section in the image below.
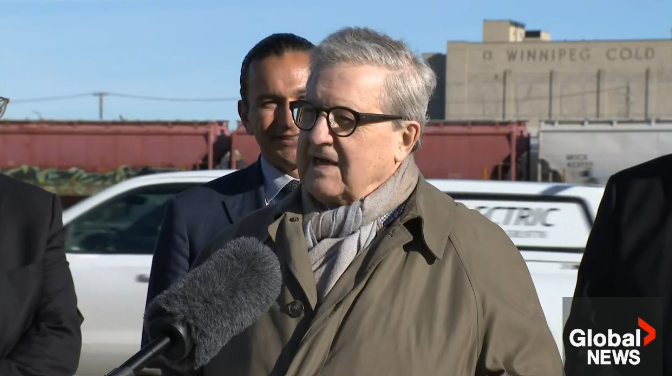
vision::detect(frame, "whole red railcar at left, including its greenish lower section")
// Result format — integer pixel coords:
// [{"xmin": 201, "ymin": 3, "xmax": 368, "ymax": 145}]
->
[{"xmin": 0, "ymin": 120, "xmax": 230, "ymax": 196}]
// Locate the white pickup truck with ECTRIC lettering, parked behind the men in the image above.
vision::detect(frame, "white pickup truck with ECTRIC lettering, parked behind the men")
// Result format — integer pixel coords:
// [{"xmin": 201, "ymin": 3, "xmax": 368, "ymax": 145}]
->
[{"xmin": 63, "ymin": 170, "xmax": 604, "ymax": 375}]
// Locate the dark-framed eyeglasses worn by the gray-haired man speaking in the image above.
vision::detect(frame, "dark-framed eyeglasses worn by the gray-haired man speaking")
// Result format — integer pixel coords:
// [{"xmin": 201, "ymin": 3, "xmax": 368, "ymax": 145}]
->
[{"xmin": 289, "ymin": 100, "xmax": 403, "ymax": 137}]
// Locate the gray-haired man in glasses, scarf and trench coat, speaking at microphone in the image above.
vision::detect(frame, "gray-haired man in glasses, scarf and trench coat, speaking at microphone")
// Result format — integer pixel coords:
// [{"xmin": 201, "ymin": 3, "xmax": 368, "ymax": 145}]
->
[{"xmin": 184, "ymin": 28, "xmax": 563, "ymax": 376}]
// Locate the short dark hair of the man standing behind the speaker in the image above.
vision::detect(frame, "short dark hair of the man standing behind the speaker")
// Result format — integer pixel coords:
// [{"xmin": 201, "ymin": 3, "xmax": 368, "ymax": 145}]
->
[{"xmin": 240, "ymin": 33, "xmax": 315, "ymax": 106}]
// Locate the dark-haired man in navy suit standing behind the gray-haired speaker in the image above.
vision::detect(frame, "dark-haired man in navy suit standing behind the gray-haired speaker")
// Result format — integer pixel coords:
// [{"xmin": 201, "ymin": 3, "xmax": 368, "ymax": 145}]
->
[{"xmin": 142, "ymin": 34, "xmax": 314, "ymax": 346}]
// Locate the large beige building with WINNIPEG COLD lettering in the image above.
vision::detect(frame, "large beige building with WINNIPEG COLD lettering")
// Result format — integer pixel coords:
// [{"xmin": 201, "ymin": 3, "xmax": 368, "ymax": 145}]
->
[{"xmin": 424, "ymin": 20, "xmax": 672, "ymax": 132}]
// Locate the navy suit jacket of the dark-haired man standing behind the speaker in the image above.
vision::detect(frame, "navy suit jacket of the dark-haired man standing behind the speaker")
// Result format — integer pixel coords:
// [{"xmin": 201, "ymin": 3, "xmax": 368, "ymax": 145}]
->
[{"xmin": 142, "ymin": 161, "xmax": 265, "ymax": 346}]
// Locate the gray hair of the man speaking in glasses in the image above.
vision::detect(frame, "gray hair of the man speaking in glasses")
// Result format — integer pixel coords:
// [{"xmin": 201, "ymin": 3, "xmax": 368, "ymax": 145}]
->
[{"xmin": 308, "ymin": 27, "xmax": 436, "ymax": 151}]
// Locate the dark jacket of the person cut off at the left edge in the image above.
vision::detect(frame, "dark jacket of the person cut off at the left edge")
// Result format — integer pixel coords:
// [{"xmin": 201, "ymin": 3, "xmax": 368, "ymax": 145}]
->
[{"xmin": 0, "ymin": 174, "xmax": 83, "ymax": 376}]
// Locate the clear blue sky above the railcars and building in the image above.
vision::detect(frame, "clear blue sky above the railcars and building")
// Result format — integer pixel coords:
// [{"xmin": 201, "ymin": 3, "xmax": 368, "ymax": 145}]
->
[{"xmin": 0, "ymin": 0, "xmax": 672, "ymax": 127}]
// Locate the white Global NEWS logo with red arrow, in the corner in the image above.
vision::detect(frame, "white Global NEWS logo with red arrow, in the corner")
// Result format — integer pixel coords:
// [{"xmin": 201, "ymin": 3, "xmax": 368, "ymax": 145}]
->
[{"xmin": 569, "ymin": 318, "xmax": 656, "ymax": 366}]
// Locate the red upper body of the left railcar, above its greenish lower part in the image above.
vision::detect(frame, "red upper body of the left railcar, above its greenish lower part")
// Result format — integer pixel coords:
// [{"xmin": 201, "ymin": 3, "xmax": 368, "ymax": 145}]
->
[{"xmin": 0, "ymin": 120, "xmax": 228, "ymax": 172}]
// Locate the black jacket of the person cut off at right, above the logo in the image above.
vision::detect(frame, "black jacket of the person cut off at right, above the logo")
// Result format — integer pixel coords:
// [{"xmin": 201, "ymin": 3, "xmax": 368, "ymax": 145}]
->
[{"xmin": 565, "ymin": 154, "xmax": 672, "ymax": 376}]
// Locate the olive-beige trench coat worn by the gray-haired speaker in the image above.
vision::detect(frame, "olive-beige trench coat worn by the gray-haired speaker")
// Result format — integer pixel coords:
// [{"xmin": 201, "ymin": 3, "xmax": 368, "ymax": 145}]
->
[{"xmin": 184, "ymin": 178, "xmax": 563, "ymax": 376}]
